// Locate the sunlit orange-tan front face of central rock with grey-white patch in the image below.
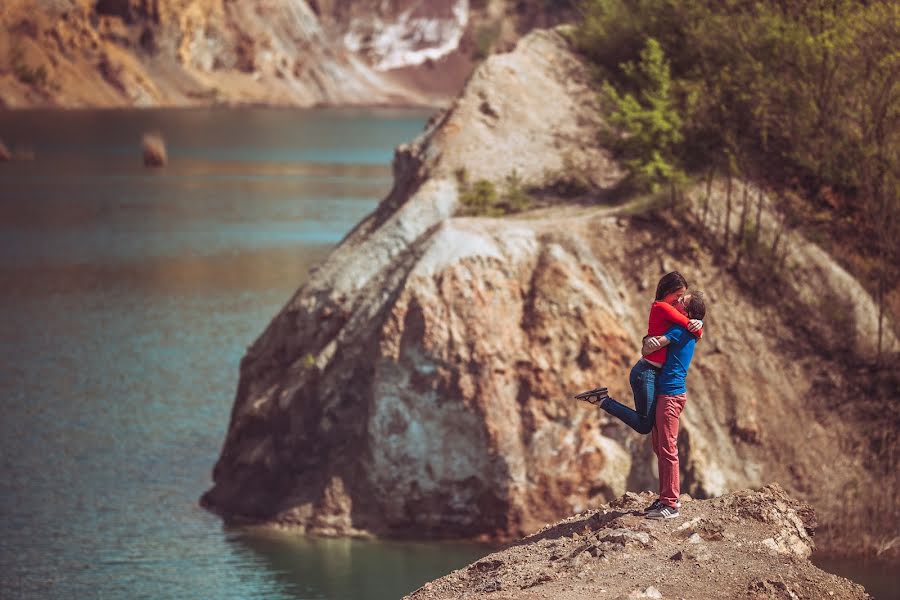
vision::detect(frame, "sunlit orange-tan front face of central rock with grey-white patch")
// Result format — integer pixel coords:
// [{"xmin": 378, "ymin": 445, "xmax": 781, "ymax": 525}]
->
[{"xmin": 363, "ymin": 222, "xmax": 631, "ymax": 534}]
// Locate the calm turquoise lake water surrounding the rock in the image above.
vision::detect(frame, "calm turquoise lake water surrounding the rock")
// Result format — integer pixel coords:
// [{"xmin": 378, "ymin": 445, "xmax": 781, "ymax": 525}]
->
[{"xmin": 0, "ymin": 109, "xmax": 898, "ymax": 600}]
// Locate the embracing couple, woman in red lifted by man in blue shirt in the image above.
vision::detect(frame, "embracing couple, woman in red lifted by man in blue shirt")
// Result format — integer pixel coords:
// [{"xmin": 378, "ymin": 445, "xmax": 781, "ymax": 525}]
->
[{"xmin": 576, "ymin": 271, "xmax": 706, "ymax": 519}]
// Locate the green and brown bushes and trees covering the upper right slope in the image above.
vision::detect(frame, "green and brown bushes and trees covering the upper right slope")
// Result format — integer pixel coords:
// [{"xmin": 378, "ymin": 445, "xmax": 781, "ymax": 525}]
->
[{"xmin": 574, "ymin": 0, "xmax": 900, "ymax": 360}]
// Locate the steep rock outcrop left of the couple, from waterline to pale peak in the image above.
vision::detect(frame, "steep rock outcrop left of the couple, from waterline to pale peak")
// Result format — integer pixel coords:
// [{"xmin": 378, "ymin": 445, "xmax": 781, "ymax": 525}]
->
[{"xmin": 205, "ymin": 32, "xmax": 634, "ymax": 537}]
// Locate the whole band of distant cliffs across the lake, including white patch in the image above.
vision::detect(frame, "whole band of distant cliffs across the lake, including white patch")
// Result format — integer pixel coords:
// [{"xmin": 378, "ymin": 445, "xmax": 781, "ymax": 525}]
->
[{"xmin": 0, "ymin": 0, "xmax": 560, "ymax": 108}]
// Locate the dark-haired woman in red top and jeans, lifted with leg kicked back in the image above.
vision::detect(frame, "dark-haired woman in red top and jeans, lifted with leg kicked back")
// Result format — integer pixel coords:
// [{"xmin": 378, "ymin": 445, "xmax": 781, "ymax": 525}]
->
[{"xmin": 578, "ymin": 271, "xmax": 703, "ymax": 435}]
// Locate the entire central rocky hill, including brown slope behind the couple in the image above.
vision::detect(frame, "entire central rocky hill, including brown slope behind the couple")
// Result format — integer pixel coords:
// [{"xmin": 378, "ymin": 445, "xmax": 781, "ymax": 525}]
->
[{"xmin": 203, "ymin": 24, "xmax": 896, "ymax": 543}]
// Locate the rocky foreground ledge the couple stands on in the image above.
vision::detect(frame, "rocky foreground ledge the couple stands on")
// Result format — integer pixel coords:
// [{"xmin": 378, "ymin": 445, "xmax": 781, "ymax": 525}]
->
[{"xmin": 406, "ymin": 485, "xmax": 869, "ymax": 600}]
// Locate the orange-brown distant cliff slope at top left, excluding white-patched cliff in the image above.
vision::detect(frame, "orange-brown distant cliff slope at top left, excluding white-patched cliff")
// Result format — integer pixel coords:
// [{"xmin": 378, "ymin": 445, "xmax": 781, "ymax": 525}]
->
[{"xmin": 0, "ymin": 0, "xmax": 428, "ymax": 106}]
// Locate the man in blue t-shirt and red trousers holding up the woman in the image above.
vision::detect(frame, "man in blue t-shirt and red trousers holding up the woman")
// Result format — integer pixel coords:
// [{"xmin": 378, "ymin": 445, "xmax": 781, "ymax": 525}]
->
[{"xmin": 641, "ymin": 292, "xmax": 706, "ymax": 519}]
